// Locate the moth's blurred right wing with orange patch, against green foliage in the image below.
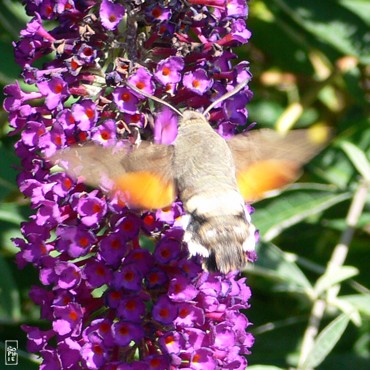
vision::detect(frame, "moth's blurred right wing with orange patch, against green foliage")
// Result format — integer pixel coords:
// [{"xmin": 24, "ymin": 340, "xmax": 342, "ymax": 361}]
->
[{"xmin": 228, "ymin": 129, "xmax": 329, "ymax": 202}]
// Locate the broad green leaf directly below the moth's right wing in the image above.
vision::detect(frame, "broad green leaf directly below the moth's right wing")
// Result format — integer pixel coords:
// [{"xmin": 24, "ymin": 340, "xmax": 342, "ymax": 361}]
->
[{"xmin": 252, "ymin": 184, "xmax": 351, "ymax": 241}]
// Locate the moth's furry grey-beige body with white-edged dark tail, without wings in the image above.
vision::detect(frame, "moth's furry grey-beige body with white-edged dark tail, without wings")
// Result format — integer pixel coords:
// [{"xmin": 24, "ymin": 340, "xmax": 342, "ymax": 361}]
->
[{"xmin": 173, "ymin": 111, "xmax": 254, "ymax": 273}]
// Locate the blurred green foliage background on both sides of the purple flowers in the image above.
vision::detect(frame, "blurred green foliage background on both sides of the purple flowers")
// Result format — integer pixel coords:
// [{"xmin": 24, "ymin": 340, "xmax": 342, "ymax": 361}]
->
[{"xmin": 0, "ymin": 0, "xmax": 370, "ymax": 370}]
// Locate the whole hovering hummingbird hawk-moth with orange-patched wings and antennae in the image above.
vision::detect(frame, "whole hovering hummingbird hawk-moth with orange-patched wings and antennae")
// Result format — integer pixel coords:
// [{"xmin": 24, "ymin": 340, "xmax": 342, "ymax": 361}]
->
[{"xmin": 51, "ymin": 83, "xmax": 330, "ymax": 273}]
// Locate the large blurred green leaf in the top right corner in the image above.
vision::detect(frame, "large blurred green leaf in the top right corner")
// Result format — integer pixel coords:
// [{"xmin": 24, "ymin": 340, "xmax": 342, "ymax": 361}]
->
[{"xmin": 274, "ymin": 0, "xmax": 370, "ymax": 63}]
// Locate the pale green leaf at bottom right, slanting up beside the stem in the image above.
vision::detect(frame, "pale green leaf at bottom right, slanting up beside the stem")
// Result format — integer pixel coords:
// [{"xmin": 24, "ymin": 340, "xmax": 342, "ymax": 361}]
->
[{"xmin": 302, "ymin": 314, "xmax": 349, "ymax": 370}]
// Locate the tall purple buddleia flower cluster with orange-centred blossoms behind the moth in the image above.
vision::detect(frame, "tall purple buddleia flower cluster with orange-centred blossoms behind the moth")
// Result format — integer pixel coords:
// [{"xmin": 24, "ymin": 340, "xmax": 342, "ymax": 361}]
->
[{"xmin": 4, "ymin": 0, "xmax": 253, "ymax": 370}]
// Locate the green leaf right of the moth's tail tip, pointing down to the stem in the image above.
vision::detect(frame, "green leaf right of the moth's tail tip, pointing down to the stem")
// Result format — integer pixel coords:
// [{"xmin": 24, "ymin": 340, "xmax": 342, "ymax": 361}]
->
[{"xmin": 247, "ymin": 242, "xmax": 312, "ymax": 292}]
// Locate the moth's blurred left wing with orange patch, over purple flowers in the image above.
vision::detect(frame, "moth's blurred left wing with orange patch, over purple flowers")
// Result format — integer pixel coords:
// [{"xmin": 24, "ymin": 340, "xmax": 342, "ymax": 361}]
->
[{"xmin": 50, "ymin": 142, "xmax": 176, "ymax": 209}]
